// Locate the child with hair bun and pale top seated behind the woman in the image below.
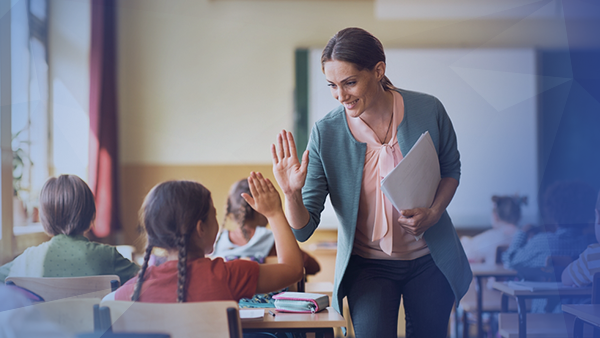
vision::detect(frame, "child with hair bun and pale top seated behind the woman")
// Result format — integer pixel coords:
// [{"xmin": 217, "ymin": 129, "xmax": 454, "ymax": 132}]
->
[{"xmin": 461, "ymin": 196, "xmax": 527, "ymax": 264}]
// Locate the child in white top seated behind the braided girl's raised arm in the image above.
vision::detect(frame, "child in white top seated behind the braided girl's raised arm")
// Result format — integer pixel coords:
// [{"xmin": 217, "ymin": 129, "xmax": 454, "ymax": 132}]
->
[{"xmin": 212, "ymin": 179, "xmax": 321, "ymax": 275}]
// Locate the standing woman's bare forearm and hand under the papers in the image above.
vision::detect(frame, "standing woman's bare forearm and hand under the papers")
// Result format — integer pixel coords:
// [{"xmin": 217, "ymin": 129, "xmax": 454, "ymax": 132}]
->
[{"xmin": 398, "ymin": 177, "xmax": 458, "ymax": 236}]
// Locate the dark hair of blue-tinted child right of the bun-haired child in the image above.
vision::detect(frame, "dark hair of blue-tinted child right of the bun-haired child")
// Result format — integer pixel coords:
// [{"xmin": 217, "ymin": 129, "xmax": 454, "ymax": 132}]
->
[{"xmin": 542, "ymin": 181, "xmax": 596, "ymax": 226}]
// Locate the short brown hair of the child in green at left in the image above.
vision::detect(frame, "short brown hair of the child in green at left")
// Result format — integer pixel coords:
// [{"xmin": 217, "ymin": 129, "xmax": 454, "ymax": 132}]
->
[{"xmin": 40, "ymin": 175, "xmax": 96, "ymax": 236}]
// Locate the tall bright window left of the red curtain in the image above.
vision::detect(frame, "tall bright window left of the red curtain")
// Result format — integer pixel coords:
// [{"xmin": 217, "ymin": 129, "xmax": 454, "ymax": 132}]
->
[{"xmin": 0, "ymin": 0, "xmax": 90, "ymax": 263}]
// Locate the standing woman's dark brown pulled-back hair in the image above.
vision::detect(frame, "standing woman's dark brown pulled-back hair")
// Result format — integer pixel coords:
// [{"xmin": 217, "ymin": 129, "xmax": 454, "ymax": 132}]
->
[{"xmin": 321, "ymin": 27, "xmax": 396, "ymax": 90}]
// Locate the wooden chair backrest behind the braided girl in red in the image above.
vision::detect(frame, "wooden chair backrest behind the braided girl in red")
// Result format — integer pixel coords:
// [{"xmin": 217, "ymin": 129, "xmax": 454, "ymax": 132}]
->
[{"xmin": 101, "ymin": 301, "xmax": 242, "ymax": 338}]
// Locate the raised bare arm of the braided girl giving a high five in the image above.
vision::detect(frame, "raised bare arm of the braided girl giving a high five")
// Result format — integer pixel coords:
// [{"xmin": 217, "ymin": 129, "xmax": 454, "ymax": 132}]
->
[{"xmin": 242, "ymin": 172, "xmax": 303, "ymax": 293}]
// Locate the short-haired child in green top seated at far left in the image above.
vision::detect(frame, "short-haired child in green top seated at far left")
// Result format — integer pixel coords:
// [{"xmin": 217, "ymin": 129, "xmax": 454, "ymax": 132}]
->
[{"xmin": 0, "ymin": 175, "xmax": 140, "ymax": 283}]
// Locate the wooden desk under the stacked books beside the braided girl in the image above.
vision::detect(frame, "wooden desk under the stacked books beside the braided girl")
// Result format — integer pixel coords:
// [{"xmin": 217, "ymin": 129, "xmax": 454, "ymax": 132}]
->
[{"xmin": 242, "ymin": 307, "xmax": 346, "ymax": 338}]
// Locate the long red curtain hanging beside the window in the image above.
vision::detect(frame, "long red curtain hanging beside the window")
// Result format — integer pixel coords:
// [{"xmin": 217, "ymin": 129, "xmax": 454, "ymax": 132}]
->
[{"xmin": 89, "ymin": 0, "xmax": 120, "ymax": 237}]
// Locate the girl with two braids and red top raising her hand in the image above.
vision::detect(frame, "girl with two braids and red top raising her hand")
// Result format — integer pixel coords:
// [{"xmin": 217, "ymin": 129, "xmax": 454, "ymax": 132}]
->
[{"xmin": 105, "ymin": 172, "xmax": 302, "ymax": 303}]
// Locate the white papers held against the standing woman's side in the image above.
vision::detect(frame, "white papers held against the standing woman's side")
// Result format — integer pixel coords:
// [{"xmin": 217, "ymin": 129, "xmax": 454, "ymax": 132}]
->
[{"xmin": 381, "ymin": 131, "xmax": 442, "ymax": 241}]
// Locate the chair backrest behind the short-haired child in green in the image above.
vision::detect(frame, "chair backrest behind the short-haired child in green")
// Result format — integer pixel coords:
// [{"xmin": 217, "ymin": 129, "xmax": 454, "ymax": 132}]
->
[{"xmin": 6, "ymin": 275, "xmax": 119, "ymax": 301}]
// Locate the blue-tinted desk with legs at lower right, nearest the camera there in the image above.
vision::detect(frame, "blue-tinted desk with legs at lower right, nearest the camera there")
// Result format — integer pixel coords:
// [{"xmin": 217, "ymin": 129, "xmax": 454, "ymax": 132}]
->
[{"xmin": 493, "ymin": 282, "xmax": 592, "ymax": 338}]
